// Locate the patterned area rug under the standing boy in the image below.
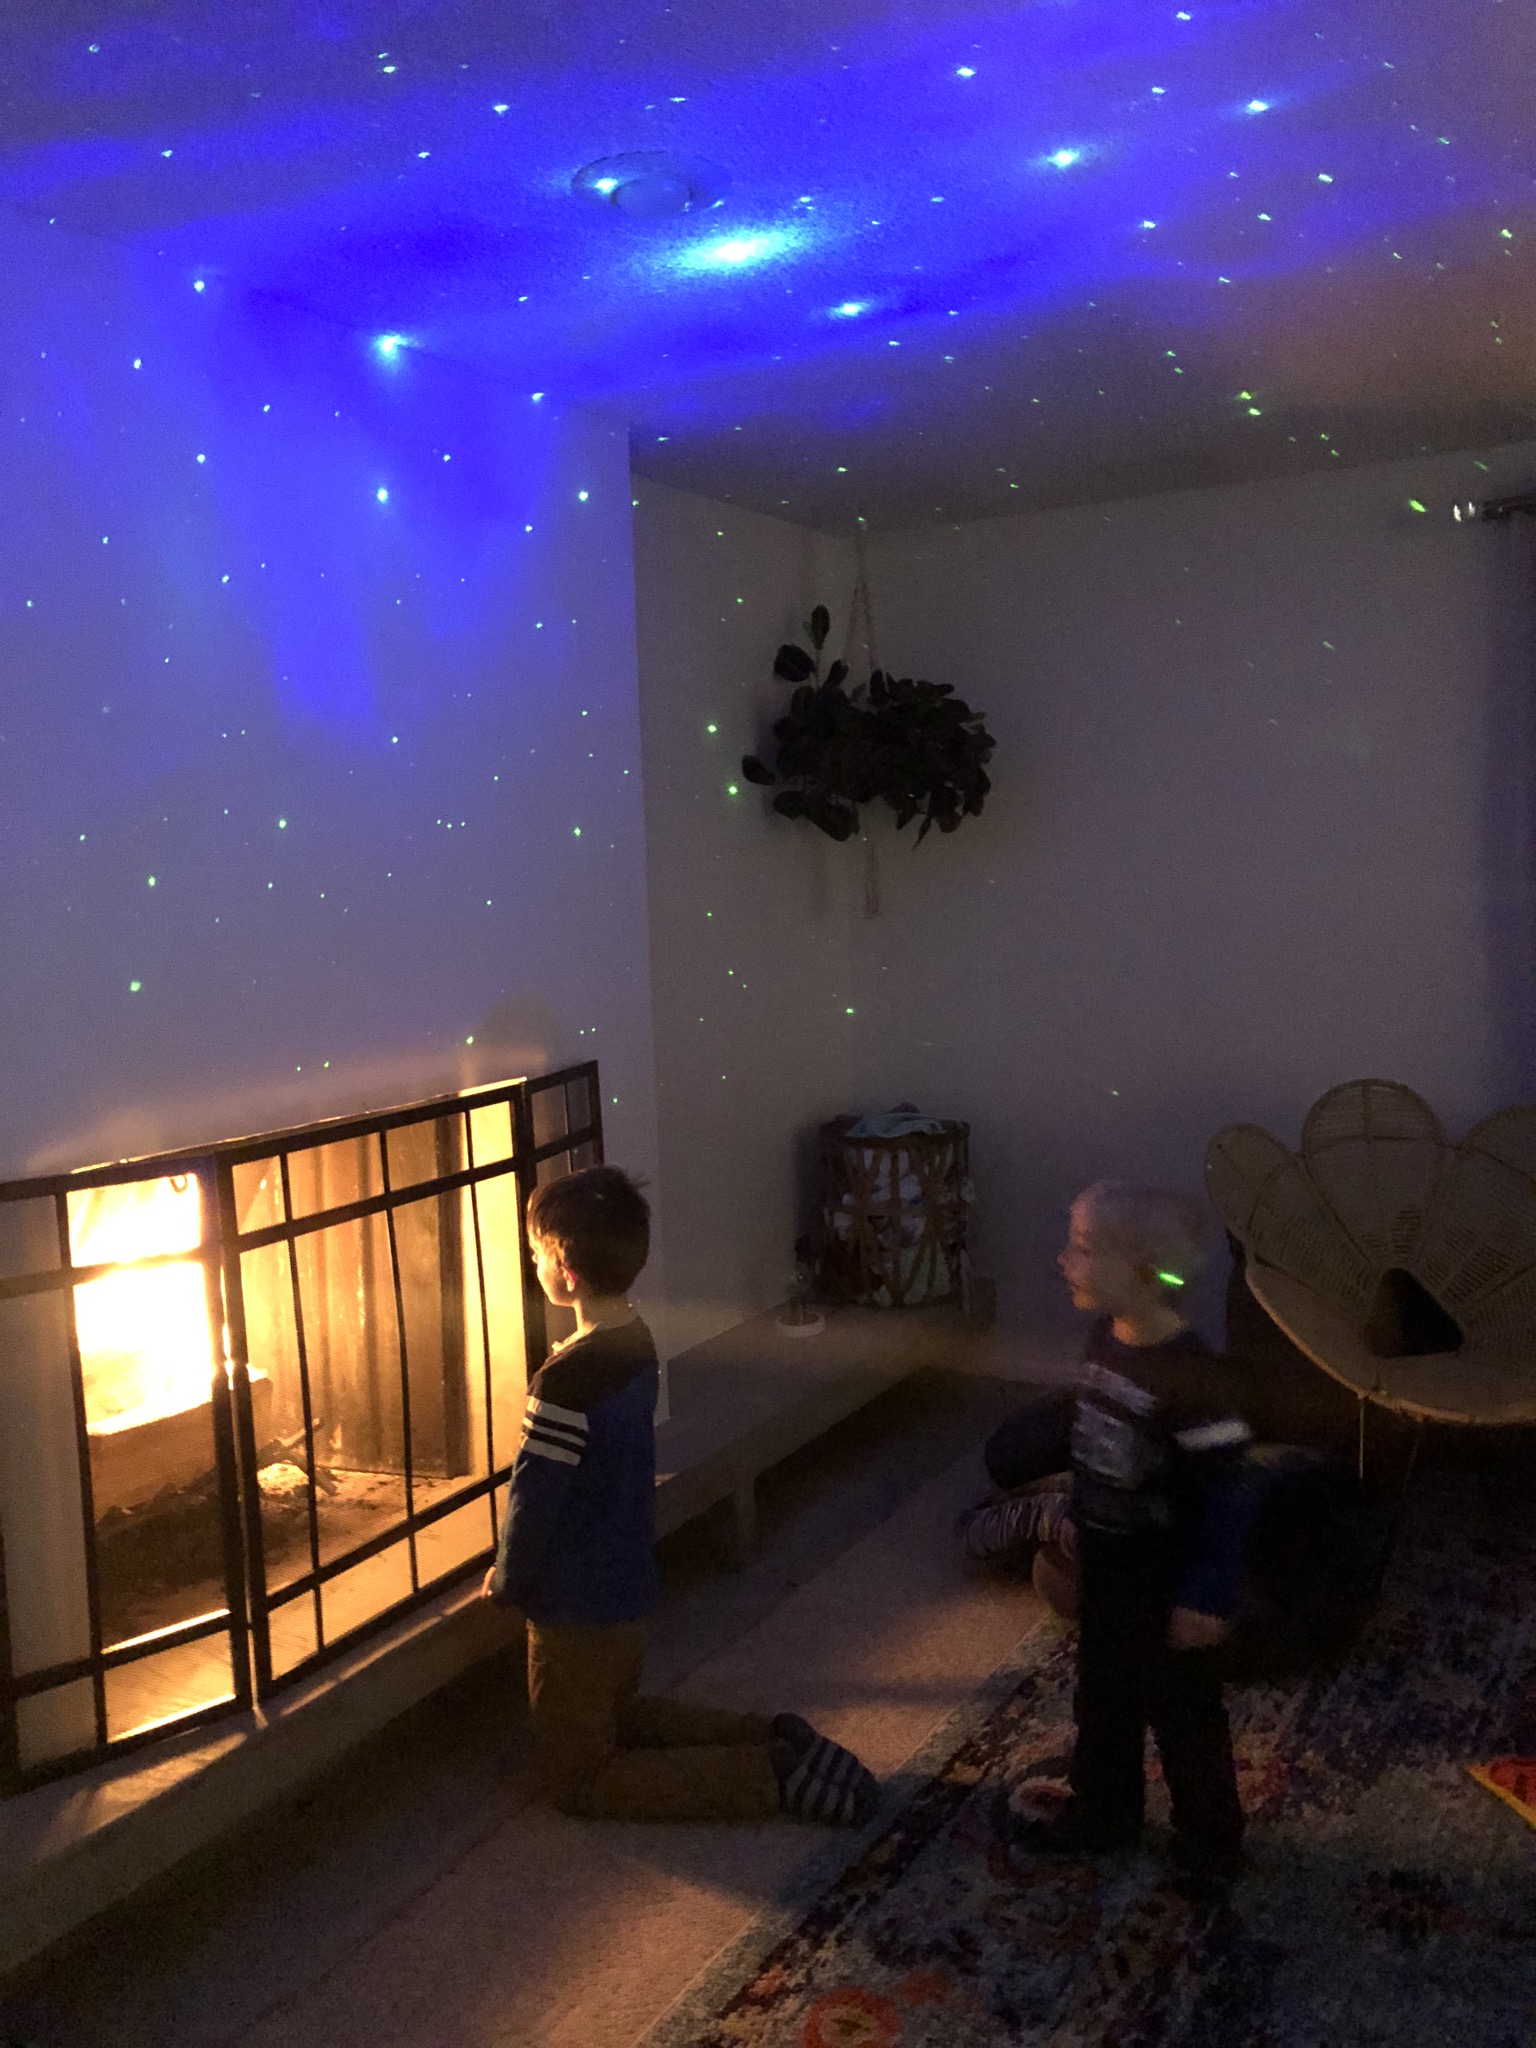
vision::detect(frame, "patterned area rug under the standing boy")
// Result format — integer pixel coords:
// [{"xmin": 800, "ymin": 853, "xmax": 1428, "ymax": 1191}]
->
[{"xmin": 645, "ymin": 1473, "xmax": 1536, "ymax": 2048}]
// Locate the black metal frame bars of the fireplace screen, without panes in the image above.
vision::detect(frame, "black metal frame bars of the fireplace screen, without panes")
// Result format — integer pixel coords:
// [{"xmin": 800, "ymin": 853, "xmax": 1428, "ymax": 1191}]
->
[{"xmin": 0, "ymin": 1061, "xmax": 602, "ymax": 1790}]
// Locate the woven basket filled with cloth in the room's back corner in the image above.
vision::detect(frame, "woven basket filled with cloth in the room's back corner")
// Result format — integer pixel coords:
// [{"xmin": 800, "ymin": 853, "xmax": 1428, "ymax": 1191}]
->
[{"xmin": 819, "ymin": 1116, "xmax": 971, "ymax": 1309}]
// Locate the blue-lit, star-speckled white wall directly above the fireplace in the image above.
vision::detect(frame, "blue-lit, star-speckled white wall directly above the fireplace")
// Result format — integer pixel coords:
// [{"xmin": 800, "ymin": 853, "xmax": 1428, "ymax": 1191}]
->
[{"xmin": 0, "ymin": 217, "xmax": 659, "ymax": 1236}]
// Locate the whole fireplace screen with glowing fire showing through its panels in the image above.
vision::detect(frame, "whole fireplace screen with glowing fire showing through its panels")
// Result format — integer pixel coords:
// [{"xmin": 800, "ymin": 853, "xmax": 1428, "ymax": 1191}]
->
[{"xmin": 0, "ymin": 1065, "xmax": 602, "ymax": 1788}]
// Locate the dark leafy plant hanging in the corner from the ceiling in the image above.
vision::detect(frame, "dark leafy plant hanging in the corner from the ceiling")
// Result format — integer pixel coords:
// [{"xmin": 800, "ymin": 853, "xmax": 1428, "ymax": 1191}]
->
[{"xmin": 741, "ymin": 604, "xmax": 997, "ymax": 842}]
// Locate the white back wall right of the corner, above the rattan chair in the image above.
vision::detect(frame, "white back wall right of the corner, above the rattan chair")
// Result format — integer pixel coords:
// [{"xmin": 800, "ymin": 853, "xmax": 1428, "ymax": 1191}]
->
[{"xmin": 852, "ymin": 446, "xmax": 1536, "ymax": 1329}]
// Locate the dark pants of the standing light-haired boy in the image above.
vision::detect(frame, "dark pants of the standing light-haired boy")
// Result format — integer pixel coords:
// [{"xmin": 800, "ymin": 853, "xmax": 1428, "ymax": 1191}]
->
[{"xmin": 1071, "ymin": 1526, "xmax": 1243, "ymax": 1853}]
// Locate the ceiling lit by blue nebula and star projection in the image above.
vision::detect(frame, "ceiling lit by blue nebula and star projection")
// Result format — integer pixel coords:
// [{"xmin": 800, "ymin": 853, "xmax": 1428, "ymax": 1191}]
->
[{"xmin": 0, "ymin": 0, "xmax": 1536, "ymax": 526}]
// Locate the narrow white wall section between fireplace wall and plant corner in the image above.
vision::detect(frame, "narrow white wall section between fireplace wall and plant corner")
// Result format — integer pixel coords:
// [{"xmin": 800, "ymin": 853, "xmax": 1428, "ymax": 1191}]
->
[{"xmin": 635, "ymin": 481, "xmax": 858, "ymax": 1350}]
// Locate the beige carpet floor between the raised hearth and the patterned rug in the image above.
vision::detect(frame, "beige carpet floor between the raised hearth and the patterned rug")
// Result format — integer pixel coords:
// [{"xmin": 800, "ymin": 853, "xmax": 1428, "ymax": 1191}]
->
[{"xmin": 0, "ymin": 1372, "xmax": 1038, "ymax": 2048}]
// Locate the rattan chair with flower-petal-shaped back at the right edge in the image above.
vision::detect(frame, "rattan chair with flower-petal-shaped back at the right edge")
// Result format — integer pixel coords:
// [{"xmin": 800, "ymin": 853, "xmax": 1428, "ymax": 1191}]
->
[{"xmin": 1206, "ymin": 1081, "xmax": 1536, "ymax": 1430}]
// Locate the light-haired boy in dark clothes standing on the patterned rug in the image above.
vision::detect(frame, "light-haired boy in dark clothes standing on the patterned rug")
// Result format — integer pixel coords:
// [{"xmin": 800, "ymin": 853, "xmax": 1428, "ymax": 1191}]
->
[{"xmin": 989, "ymin": 1182, "xmax": 1249, "ymax": 1892}]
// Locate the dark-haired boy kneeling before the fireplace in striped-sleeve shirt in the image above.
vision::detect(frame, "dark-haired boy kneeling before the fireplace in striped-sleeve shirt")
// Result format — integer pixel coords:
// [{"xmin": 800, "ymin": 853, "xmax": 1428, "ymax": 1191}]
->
[{"xmin": 483, "ymin": 1165, "xmax": 879, "ymax": 1825}]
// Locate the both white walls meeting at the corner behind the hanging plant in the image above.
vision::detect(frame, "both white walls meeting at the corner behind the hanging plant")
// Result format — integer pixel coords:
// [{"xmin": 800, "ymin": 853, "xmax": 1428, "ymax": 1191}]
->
[{"xmin": 637, "ymin": 449, "xmax": 1536, "ymax": 1360}]
